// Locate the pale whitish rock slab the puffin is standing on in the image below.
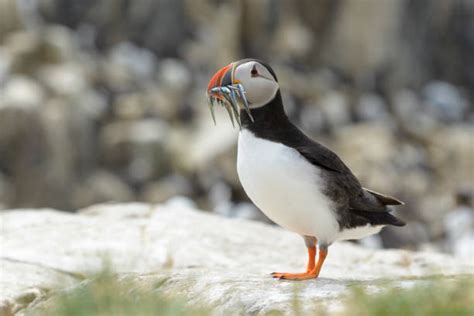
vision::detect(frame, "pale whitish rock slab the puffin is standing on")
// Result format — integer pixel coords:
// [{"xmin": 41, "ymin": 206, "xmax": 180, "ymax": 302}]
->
[{"xmin": 0, "ymin": 203, "xmax": 474, "ymax": 314}]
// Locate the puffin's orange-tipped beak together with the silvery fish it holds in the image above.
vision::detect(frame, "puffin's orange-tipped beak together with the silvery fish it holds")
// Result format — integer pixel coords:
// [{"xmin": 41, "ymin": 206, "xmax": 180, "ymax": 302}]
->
[{"xmin": 207, "ymin": 63, "xmax": 253, "ymax": 128}]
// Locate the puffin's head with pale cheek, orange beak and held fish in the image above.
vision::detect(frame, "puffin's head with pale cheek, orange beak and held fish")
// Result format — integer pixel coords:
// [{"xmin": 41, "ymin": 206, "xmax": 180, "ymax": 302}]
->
[{"xmin": 207, "ymin": 59, "xmax": 280, "ymax": 125}]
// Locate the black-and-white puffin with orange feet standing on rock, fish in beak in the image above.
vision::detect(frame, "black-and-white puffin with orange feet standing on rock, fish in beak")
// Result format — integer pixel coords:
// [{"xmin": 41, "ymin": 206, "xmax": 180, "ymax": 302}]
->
[{"xmin": 207, "ymin": 59, "xmax": 405, "ymax": 280}]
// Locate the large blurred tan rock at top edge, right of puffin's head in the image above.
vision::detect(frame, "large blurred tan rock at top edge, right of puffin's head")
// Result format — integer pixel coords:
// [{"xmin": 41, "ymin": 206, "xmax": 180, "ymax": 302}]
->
[{"xmin": 321, "ymin": 0, "xmax": 404, "ymax": 77}]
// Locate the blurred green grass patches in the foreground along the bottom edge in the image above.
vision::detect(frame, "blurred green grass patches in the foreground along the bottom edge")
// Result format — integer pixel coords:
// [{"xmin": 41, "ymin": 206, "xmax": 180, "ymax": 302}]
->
[{"xmin": 29, "ymin": 272, "xmax": 474, "ymax": 316}]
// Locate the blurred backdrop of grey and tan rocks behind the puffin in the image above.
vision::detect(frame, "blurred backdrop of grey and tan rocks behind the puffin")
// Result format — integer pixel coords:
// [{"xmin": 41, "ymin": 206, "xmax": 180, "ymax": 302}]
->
[{"xmin": 0, "ymin": 0, "xmax": 474, "ymax": 255}]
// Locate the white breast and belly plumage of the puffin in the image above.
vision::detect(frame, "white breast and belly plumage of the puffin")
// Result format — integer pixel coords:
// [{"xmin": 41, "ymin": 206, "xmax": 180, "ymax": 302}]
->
[{"xmin": 237, "ymin": 130, "xmax": 339, "ymax": 243}]
